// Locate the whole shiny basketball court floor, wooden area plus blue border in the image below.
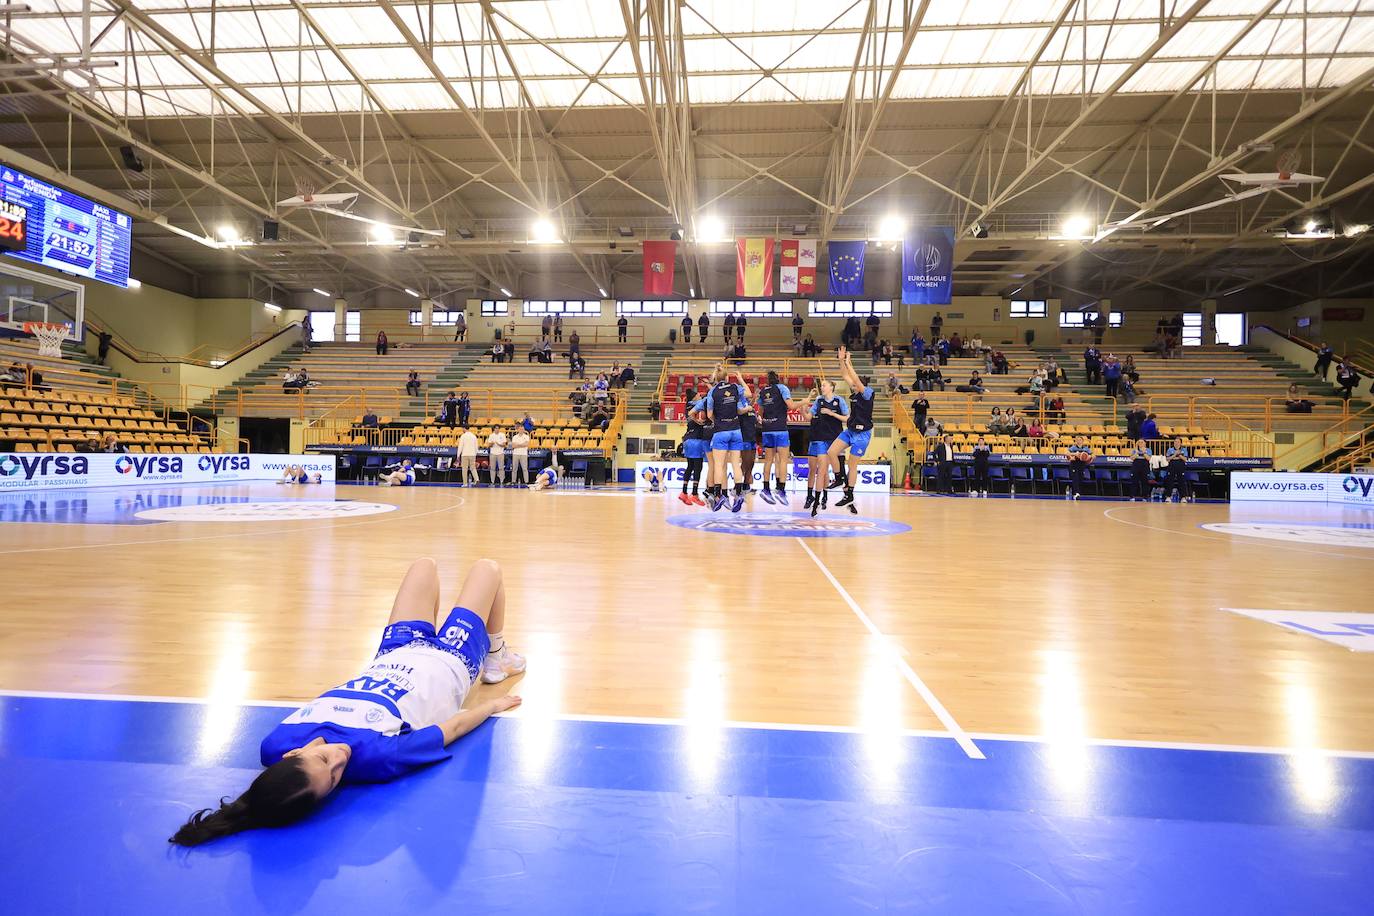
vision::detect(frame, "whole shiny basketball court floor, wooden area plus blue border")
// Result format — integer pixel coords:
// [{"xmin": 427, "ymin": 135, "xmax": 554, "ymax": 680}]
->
[{"xmin": 0, "ymin": 485, "xmax": 1374, "ymax": 913}]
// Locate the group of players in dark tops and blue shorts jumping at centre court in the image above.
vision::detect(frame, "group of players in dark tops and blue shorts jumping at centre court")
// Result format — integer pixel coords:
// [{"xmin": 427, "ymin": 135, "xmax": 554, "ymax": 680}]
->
[{"xmin": 676, "ymin": 347, "xmax": 874, "ymax": 516}]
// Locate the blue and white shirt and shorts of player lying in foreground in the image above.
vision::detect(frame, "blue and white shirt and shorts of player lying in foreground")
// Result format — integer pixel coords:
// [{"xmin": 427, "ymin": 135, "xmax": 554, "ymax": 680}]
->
[{"xmin": 258, "ymin": 607, "xmax": 491, "ymax": 783}]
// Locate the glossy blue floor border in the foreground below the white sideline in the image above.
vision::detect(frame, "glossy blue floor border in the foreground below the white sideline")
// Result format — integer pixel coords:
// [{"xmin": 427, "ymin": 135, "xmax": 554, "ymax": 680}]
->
[{"xmin": 0, "ymin": 695, "xmax": 1374, "ymax": 916}]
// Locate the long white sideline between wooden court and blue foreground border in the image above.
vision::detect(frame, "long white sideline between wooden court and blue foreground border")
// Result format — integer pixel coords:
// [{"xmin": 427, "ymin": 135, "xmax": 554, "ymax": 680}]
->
[{"xmin": 0, "ymin": 689, "xmax": 1374, "ymax": 759}]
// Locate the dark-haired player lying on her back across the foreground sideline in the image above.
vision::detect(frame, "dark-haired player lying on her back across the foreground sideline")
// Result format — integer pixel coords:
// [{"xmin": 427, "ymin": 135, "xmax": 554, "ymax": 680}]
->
[{"xmin": 170, "ymin": 558, "xmax": 525, "ymax": 846}]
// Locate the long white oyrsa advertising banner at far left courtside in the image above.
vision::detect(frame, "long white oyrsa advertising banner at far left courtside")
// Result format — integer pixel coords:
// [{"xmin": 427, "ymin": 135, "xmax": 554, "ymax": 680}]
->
[{"xmin": 0, "ymin": 452, "xmax": 334, "ymax": 490}]
